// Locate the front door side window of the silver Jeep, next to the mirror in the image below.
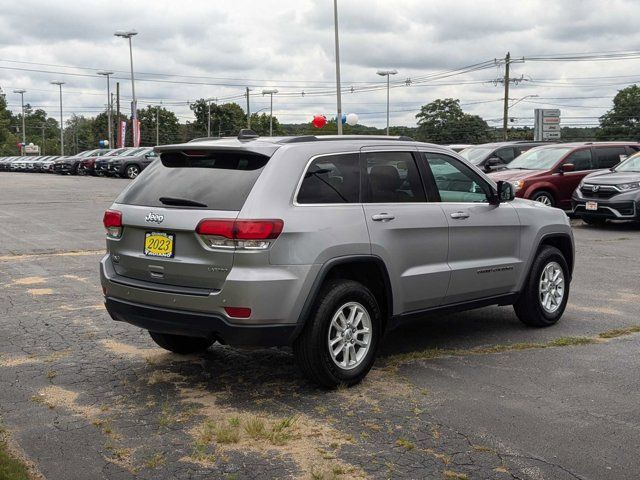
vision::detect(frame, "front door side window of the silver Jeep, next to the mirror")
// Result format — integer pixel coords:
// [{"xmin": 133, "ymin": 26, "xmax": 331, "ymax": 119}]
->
[{"xmin": 423, "ymin": 153, "xmax": 489, "ymax": 203}]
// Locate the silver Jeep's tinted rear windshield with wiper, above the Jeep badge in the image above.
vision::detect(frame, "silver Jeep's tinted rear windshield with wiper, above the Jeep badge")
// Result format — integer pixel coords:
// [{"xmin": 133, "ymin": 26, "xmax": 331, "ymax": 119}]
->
[{"xmin": 116, "ymin": 151, "xmax": 269, "ymax": 211}]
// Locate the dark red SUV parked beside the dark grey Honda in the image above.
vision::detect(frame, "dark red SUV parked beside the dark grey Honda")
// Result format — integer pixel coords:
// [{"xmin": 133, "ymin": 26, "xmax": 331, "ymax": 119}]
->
[{"xmin": 489, "ymin": 142, "xmax": 640, "ymax": 210}]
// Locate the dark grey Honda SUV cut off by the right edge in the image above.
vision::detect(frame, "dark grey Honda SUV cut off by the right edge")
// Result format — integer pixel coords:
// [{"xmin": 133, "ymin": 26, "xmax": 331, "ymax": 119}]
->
[{"xmin": 571, "ymin": 153, "xmax": 640, "ymax": 224}]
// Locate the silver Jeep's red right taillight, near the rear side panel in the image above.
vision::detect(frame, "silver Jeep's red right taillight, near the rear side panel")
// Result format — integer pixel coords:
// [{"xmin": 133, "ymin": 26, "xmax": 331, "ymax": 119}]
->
[{"xmin": 196, "ymin": 218, "xmax": 284, "ymax": 250}]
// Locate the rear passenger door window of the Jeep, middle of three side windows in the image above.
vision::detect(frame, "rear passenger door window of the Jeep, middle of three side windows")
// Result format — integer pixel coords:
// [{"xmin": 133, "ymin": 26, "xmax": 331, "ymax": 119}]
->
[{"xmin": 364, "ymin": 152, "xmax": 426, "ymax": 203}]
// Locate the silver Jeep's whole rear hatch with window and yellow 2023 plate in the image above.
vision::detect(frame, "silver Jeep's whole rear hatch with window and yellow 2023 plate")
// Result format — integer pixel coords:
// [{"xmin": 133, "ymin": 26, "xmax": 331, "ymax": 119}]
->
[{"xmin": 108, "ymin": 146, "xmax": 273, "ymax": 290}]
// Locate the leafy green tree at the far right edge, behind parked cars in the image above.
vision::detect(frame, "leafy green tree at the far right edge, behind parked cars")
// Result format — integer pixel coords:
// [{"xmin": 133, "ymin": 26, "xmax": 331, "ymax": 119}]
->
[{"xmin": 596, "ymin": 85, "xmax": 640, "ymax": 140}]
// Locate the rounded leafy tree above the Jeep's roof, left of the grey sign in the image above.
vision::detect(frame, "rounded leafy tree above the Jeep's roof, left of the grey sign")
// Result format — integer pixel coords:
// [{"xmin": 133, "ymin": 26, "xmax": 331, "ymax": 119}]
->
[{"xmin": 416, "ymin": 98, "xmax": 489, "ymax": 144}]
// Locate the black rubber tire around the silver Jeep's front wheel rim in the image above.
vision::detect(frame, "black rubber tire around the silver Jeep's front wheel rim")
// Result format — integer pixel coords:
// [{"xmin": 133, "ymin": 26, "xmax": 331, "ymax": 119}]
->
[{"xmin": 513, "ymin": 246, "xmax": 570, "ymax": 327}]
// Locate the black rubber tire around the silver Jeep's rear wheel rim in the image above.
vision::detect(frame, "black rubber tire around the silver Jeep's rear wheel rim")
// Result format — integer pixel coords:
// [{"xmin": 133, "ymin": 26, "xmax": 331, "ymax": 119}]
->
[{"xmin": 293, "ymin": 280, "xmax": 382, "ymax": 388}]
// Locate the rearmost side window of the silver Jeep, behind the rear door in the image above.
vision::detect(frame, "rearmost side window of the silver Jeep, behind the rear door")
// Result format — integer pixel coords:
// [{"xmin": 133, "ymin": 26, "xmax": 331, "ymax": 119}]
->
[{"xmin": 298, "ymin": 153, "xmax": 360, "ymax": 204}]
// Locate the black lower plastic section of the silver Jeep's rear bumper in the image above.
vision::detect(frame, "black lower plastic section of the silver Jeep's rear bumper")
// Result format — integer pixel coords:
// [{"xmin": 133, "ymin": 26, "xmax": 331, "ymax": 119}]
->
[{"xmin": 105, "ymin": 297, "xmax": 296, "ymax": 347}]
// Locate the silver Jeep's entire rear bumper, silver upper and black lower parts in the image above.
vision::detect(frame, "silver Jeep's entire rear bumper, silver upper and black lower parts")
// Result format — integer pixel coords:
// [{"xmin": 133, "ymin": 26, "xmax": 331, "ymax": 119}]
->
[{"xmin": 100, "ymin": 254, "xmax": 315, "ymax": 346}]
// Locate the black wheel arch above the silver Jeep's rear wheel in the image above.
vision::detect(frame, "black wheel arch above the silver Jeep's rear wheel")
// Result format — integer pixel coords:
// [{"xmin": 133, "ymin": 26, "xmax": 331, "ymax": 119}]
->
[{"xmin": 290, "ymin": 255, "xmax": 393, "ymax": 342}]
